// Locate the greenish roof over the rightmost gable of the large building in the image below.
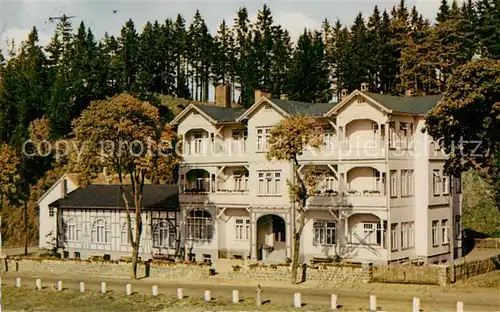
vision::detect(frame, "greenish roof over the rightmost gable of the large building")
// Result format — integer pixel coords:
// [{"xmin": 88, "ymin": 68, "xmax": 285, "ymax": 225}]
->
[{"xmin": 324, "ymin": 90, "xmax": 444, "ymax": 116}]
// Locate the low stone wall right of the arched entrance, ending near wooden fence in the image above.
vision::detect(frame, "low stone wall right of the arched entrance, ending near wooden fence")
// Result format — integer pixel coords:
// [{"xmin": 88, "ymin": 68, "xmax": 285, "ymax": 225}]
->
[{"xmin": 229, "ymin": 264, "xmax": 372, "ymax": 284}]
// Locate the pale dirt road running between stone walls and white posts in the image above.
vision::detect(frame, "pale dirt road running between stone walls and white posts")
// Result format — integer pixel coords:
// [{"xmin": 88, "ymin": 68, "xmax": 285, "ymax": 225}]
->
[{"xmin": 2, "ymin": 272, "xmax": 500, "ymax": 312}]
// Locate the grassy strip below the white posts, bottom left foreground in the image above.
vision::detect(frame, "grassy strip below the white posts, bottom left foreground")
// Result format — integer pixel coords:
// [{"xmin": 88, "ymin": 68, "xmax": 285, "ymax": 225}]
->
[{"xmin": 2, "ymin": 286, "xmax": 325, "ymax": 312}]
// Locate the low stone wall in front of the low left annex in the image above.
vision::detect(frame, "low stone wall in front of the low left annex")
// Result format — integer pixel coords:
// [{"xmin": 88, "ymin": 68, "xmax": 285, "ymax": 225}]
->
[{"xmin": 2, "ymin": 259, "xmax": 211, "ymax": 280}]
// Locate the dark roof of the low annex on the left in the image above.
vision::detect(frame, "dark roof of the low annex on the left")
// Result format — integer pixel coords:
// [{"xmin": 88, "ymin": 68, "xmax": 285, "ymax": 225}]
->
[{"xmin": 49, "ymin": 184, "xmax": 179, "ymax": 211}]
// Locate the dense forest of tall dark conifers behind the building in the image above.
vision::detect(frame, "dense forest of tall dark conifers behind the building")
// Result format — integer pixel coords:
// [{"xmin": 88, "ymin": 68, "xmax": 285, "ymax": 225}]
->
[{"xmin": 0, "ymin": 0, "xmax": 500, "ymax": 245}]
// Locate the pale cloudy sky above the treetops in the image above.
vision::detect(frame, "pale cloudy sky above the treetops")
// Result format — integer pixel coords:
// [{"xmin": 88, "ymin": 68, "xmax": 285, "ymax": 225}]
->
[{"xmin": 0, "ymin": 0, "xmax": 458, "ymax": 49}]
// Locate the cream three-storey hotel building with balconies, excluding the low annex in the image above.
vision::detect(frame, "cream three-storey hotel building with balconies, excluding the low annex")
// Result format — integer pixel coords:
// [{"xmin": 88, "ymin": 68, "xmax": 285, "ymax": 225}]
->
[{"xmin": 172, "ymin": 86, "xmax": 461, "ymax": 263}]
